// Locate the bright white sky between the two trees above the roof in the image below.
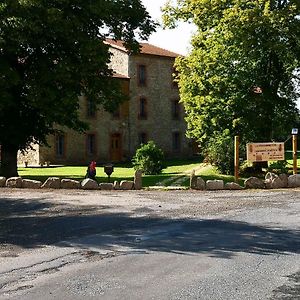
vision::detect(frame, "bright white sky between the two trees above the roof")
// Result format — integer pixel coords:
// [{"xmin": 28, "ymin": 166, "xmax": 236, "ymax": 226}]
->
[{"xmin": 142, "ymin": 0, "xmax": 193, "ymax": 55}]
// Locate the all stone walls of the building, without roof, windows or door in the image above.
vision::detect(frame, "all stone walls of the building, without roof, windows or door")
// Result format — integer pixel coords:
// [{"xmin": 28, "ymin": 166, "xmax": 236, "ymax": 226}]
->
[{"xmin": 20, "ymin": 48, "xmax": 193, "ymax": 165}]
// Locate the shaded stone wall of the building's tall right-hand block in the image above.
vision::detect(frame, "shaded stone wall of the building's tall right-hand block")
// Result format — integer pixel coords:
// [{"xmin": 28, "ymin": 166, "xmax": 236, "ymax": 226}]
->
[{"xmin": 129, "ymin": 55, "xmax": 192, "ymax": 157}]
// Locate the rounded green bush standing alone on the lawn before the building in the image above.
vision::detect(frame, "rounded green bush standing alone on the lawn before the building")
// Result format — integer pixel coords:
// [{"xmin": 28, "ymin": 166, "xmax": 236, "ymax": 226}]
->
[{"xmin": 132, "ymin": 141, "xmax": 164, "ymax": 175}]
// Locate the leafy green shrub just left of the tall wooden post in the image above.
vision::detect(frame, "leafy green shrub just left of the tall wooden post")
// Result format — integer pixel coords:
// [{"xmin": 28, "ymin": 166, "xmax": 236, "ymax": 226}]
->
[{"xmin": 205, "ymin": 130, "xmax": 234, "ymax": 175}]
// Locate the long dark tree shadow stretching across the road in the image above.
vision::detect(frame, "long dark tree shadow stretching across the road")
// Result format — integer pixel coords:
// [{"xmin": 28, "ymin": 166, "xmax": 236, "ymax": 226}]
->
[{"xmin": 0, "ymin": 199, "xmax": 300, "ymax": 258}]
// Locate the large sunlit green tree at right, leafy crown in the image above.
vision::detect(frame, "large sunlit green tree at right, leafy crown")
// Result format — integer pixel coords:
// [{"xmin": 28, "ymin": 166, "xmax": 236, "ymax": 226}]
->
[{"xmin": 164, "ymin": 0, "xmax": 300, "ymax": 172}]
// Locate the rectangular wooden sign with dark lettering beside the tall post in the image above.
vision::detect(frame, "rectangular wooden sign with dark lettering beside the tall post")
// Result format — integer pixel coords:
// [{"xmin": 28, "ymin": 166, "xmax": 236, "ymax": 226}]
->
[{"xmin": 247, "ymin": 143, "xmax": 284, "ymax": 162}]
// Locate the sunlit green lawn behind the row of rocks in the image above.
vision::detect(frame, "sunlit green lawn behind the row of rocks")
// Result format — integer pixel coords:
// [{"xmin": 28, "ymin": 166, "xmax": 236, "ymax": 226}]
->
[{"xmin": 18, "ymin": 152, "xmax": 300, "ymax": 187}]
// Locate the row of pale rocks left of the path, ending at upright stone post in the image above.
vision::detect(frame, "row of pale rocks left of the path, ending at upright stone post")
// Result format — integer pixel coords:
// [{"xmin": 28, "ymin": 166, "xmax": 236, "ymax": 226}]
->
[{"xmin": 0, "ymin": 171, "xmax": 142, "ymax": 190}]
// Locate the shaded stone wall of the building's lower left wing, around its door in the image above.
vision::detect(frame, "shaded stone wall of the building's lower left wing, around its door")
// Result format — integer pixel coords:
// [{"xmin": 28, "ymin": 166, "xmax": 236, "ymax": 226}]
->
[{"xmin": 40, "ymin": 89, "xmax": 129, "ymax": 165}]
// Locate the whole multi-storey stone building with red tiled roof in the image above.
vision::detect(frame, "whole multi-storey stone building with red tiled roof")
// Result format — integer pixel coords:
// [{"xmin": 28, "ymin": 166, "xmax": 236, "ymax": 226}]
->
[{"xmin": 19, "ymin": 40, "xmax": 193, "ymax": 165}]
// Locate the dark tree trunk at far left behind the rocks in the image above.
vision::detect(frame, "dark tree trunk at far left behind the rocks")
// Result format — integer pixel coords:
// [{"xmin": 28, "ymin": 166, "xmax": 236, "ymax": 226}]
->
[{"xmin": 0, "ymin": 144, "xmax": 18, "ymax": 178}]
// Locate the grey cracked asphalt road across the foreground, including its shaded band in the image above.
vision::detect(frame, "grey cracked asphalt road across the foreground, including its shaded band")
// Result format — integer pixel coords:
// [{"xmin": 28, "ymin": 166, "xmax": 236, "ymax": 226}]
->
[{"xmin": 0, "ymin": 189, "xmax": 300, "ymax": 300}]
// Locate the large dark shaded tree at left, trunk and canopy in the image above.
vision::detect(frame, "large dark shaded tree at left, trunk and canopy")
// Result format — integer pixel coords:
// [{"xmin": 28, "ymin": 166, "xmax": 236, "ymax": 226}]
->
[{"xmin": 0, "ymin": 0, "xmax": 156, "ymax": 177}]
